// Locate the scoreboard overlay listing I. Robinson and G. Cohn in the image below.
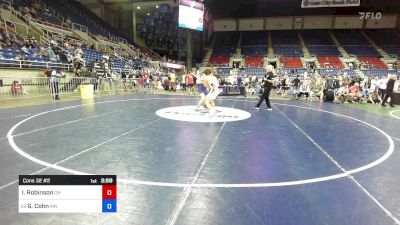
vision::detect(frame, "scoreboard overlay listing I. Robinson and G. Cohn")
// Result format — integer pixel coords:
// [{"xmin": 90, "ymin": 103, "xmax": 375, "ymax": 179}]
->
[{"xmin": 18, "ymin": 175, "xmax": 117, "ymax": 213}]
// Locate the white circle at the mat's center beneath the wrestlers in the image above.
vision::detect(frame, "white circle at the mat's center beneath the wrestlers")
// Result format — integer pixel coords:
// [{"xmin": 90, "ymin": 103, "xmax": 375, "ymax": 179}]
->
[{"xmin": 156, "ymin": 106, "xmax": 251, "ymax": 123}]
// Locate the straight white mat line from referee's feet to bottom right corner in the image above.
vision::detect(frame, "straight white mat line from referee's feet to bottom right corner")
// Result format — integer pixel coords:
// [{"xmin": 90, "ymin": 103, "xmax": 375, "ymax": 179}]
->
[{"xmin": 274, "ymin": 107, "xmax": 400, "ymax": 225}]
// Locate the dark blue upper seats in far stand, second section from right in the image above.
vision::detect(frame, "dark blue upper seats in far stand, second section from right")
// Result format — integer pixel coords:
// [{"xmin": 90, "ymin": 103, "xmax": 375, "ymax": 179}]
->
[{"xmin": 334, "ymin": 30, "xmax": 380, "ymax": 57}]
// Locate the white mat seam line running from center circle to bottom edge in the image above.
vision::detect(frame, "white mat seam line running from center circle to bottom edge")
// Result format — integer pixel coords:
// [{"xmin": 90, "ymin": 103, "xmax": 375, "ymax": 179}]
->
[{"xmin": 166, "ymin": 101, "xmax": 236, "ymax": 225}]
